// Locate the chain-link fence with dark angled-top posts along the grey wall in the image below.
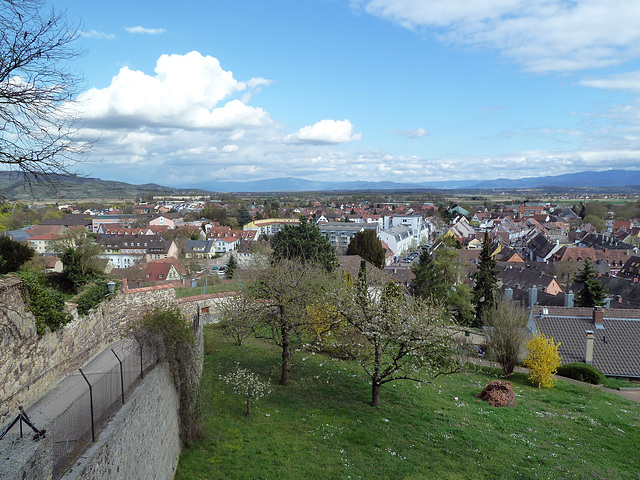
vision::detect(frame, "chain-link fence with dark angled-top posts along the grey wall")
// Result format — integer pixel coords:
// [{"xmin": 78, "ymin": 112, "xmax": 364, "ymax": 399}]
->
[{"xmin": 0, "ymin": 311, "xmax": 201, "ymax": 480}]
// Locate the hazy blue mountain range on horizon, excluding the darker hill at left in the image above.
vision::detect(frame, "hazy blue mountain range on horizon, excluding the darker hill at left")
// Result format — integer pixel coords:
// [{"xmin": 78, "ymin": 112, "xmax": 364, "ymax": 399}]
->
[{"xmin": 194, "ymin": 170, "xmax": 640, "ymax": 192}]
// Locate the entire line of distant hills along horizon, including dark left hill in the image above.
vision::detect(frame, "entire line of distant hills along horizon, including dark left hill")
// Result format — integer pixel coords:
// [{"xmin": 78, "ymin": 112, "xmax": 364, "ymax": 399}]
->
[{"xmin": 0, "ymin": 170, "xmax": 640, "ymax": 201}]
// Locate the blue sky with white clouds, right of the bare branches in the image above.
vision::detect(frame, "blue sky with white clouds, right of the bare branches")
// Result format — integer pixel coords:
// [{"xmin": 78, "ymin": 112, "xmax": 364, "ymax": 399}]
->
[{"xmin": 53, "ymin": 0, "xmax": 640, "ymax": 187}]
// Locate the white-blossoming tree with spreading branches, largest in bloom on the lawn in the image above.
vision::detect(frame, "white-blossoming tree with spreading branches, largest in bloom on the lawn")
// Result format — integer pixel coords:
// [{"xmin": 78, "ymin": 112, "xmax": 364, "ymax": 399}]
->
[{"xmin": 337, "ymin": 260, "xmax": 459, "ymax": 406}]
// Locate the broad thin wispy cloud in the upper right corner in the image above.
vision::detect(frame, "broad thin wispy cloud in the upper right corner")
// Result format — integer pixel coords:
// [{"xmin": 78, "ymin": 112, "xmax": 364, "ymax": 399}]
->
[{"xmin": 352, "ymin": 0, "xmax": 640, "ymax": 72}]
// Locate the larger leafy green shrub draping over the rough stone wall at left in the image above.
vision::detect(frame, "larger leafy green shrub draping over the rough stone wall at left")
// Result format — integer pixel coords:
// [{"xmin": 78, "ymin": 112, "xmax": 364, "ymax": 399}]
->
[{"xmin": 16, "ymin": 270, "xmax": 73, "ymax": 335}]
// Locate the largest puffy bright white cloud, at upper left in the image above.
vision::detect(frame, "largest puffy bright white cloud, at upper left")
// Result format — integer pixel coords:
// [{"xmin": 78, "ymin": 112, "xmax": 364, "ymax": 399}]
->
[{"xmin": 78, "ymin": 52, "xmax": 271, "ymax": 129}]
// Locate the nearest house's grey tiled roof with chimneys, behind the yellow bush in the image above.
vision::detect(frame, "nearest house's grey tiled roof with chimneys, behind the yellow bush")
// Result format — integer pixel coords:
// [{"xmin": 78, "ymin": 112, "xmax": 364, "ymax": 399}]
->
[{"xmin": 527, "ymin": 305, "xmax": 640, "ymax": 379}]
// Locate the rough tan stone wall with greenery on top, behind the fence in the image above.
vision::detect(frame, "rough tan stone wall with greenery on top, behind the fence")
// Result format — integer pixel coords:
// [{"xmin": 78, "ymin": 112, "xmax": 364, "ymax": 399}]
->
[{"xmin": 0, "ymin": 276, "xmax": 176, "ymax": 428}]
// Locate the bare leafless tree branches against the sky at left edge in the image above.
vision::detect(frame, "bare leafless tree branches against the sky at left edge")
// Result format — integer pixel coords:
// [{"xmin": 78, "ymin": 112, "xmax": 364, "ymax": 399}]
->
[{"xmin": 0, "ymin": 0, "xmax": 88, "ymax": 185}]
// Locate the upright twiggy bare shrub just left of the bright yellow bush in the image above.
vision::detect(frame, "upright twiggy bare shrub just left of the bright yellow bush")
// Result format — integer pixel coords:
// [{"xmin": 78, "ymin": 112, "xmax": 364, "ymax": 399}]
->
[{"xmin": 484, "ymin": 302, "xmax": 527, "ymax": 376}]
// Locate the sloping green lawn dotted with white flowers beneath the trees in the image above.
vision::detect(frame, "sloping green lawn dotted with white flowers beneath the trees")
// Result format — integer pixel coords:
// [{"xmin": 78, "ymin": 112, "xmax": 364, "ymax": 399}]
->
[{"xmin": 175, "ymin": 328, "xmax": 640, "ymax": 480}]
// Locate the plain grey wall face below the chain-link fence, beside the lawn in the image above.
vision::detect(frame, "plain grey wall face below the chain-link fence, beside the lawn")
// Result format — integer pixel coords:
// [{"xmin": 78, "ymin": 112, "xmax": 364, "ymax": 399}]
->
[{"xmin": 62, "ymin": 364, "xmax": 180, "ymax": 480}]
